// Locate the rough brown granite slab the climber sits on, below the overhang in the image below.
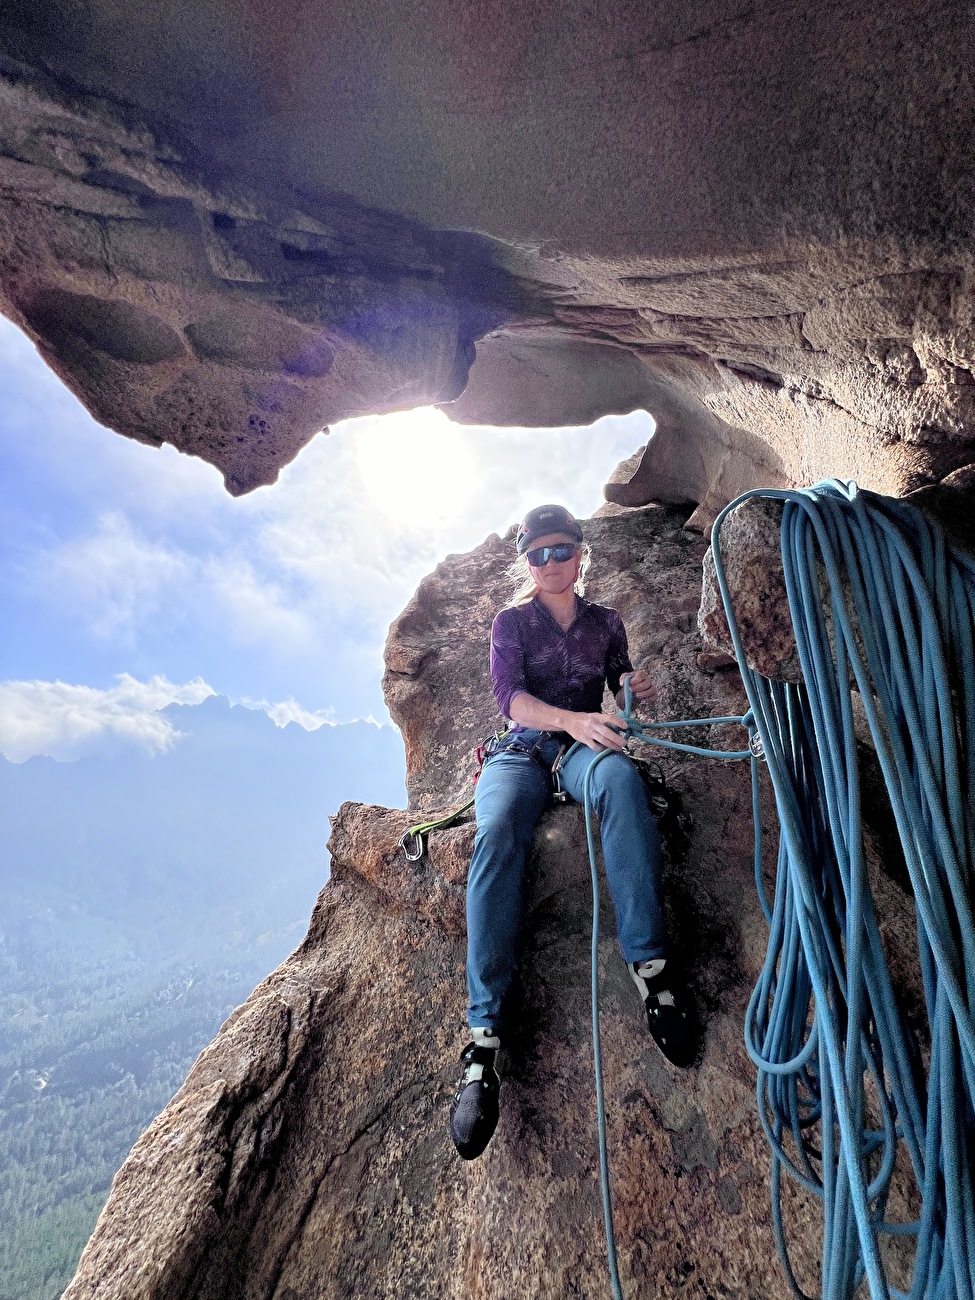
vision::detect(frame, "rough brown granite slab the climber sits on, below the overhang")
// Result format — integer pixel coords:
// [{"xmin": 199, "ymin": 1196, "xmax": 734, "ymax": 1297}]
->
[{"xmin": 65, "ymin": 507, "xmax": 930, "ymax": 1300}]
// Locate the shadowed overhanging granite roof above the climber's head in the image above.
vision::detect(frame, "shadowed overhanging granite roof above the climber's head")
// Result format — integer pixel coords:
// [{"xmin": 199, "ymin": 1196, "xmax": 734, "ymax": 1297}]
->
[{"xmin": 0, "ymin": 0, "xmax": 975, "ymax": 501}]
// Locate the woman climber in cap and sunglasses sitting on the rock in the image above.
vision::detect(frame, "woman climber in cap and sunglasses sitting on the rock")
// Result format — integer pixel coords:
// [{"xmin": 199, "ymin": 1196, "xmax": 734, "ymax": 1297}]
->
[{"xmin": 450, "ymin": 506, "xmax": 696, "ymax": 1160}]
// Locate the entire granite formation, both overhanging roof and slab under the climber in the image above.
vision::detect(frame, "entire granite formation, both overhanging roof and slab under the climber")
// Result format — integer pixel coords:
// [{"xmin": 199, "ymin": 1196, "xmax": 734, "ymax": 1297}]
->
[{"xmin": 0, "ymin": 0, "xmax": 975, "ymax": 1300}]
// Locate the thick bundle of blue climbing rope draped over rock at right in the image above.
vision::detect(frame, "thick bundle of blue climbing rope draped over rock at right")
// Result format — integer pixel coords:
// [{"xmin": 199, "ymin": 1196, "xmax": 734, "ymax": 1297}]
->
[{"xmin": 712, "ymin": 481, "xmax": 975, "ymax": 1300}]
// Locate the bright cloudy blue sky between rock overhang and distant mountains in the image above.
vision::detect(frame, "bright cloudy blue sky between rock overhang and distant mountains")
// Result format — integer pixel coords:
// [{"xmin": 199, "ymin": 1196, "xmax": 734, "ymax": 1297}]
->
[{"xmin": 0, "ymin": 319, "xmax": 653, "ymax": 762}]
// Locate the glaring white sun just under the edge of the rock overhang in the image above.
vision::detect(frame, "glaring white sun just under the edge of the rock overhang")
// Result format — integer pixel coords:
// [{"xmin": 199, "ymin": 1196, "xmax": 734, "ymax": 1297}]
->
[{"xmin": 355, "ymin": 407, "xmax": 475, "ymax": 529}]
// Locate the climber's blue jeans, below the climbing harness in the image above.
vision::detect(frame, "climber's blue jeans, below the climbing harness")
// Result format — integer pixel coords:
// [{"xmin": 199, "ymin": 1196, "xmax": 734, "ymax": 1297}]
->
[{"xmin": 467, "ymin": 731, "xmax": 668, "ymax": 1030}]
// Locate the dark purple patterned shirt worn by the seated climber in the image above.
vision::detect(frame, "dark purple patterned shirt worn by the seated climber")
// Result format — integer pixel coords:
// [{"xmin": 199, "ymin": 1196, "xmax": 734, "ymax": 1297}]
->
[{"xmin": 491, "ymin": 595, "xmax": 633, "ymax": 729}]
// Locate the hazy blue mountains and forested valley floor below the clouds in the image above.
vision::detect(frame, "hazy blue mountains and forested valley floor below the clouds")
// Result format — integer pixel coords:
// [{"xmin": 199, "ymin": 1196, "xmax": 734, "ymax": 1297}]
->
[{"xmin": 0, "ymin": 698, "xmax": 403, "ymax": 1300}]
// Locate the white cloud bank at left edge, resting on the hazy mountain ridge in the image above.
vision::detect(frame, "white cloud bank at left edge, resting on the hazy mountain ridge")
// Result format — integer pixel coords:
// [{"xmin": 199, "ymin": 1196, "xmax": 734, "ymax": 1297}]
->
[{"xmin": 0, "ymin": 672, "xmax": 215, "ymax": 763}]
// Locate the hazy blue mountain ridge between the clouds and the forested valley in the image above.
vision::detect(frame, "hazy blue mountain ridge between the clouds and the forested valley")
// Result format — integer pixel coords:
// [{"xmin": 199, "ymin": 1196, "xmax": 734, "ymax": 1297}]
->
[{"xmin": 0, "ymin": 696, "xmax": 403, "ymax": 969}]
